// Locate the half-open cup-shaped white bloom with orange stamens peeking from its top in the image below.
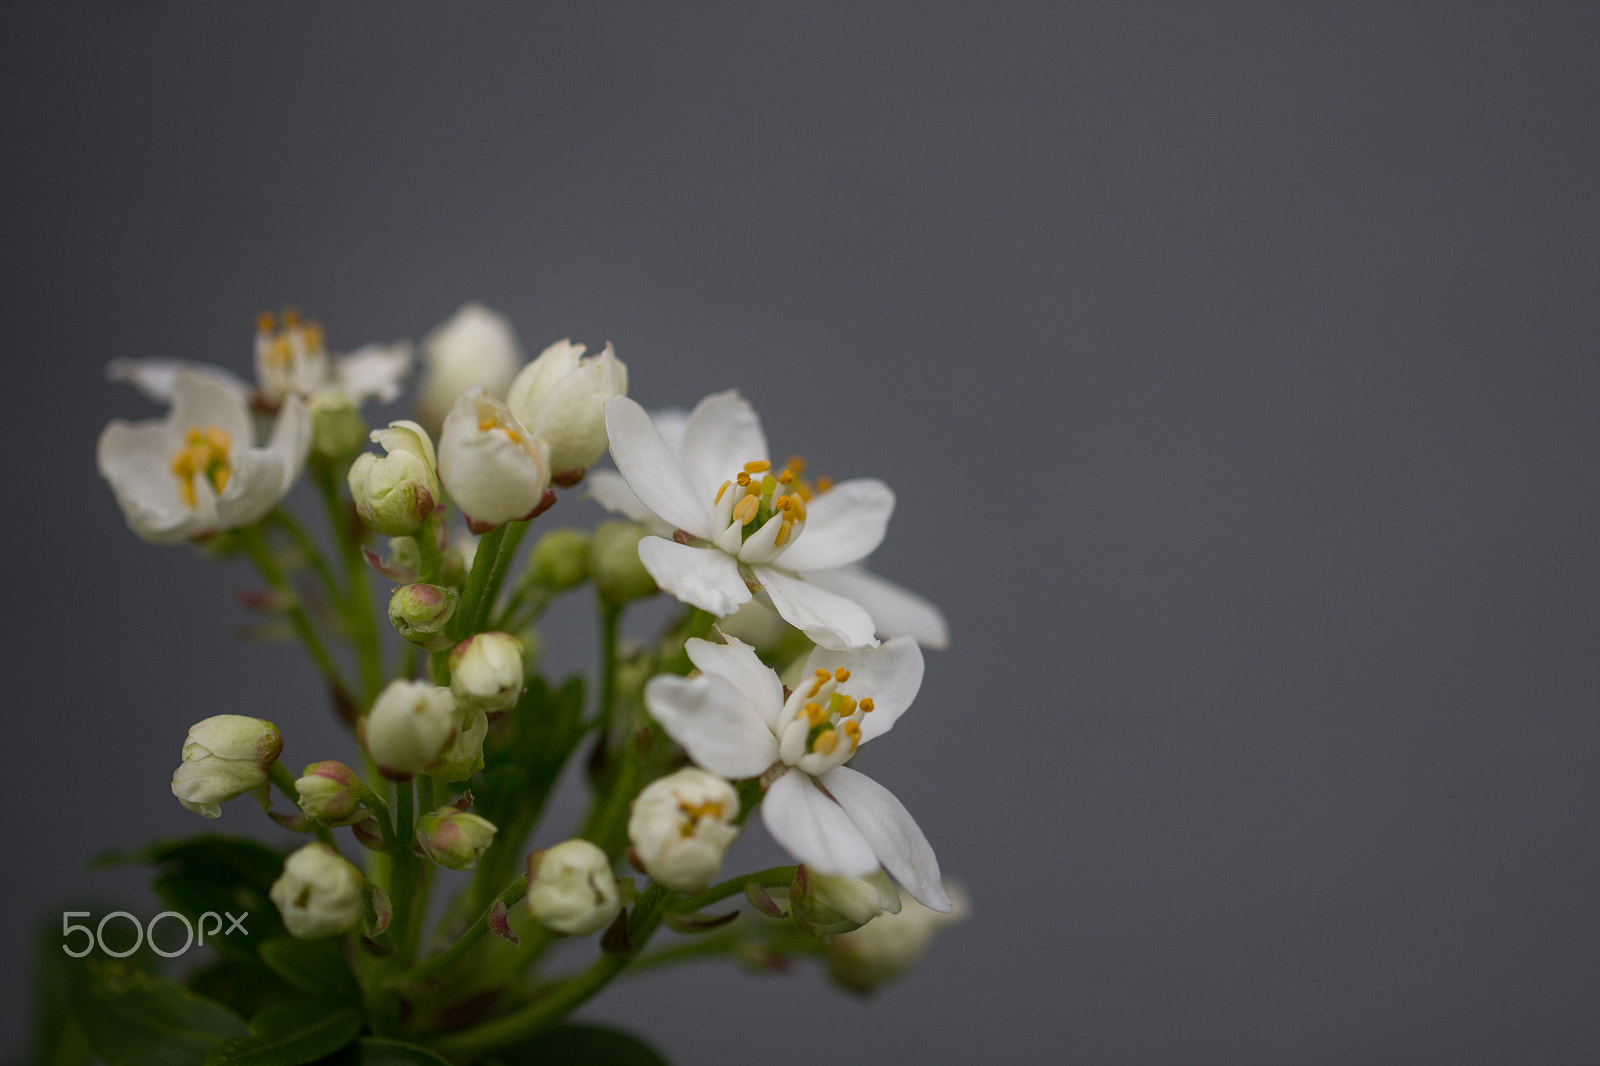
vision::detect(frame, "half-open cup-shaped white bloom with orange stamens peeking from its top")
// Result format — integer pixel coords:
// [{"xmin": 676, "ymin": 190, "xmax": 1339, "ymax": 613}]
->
[{"xmin": 438, "ymin": 387, "xmax": 550, "ymax": 531}]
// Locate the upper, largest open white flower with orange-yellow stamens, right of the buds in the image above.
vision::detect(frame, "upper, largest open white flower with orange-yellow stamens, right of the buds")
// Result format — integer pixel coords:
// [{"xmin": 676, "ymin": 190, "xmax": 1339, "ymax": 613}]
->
[{"xmin": 590, "ymin": 392, "xmax": 946, "ymax": 648}]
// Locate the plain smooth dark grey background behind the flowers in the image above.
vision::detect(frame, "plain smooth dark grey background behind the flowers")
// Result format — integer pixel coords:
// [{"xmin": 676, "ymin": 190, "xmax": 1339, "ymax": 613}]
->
[{"xmin": 0, "ymin": 2, "xmax": 1600, "ymax": 1063}]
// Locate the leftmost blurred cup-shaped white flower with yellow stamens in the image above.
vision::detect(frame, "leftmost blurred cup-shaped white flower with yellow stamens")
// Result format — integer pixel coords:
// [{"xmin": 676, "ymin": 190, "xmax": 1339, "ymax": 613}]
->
[{"xmin": 96, "ymin": 371, "xmax": 310, "ymax": 544}]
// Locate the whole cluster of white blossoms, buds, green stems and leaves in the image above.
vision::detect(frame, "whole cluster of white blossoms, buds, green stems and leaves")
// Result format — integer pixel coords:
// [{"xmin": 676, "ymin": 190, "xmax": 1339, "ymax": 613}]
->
[{"xmin": 62, "ymin": 304, "xmax": 960, "ymax": 1066}]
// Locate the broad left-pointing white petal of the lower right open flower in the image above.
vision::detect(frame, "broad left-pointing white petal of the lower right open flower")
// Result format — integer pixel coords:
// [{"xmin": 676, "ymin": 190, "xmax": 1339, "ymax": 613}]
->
[{"xmin": 645, "ymin": 674, "xmax": 778, "ymax": 779}]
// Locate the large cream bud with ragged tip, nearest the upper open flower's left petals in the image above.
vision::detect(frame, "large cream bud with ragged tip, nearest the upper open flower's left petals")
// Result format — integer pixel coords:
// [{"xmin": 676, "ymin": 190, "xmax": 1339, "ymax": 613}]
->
[{"xmin": 506, "ymin": 341, "xmax": 627, "ymax": 475}]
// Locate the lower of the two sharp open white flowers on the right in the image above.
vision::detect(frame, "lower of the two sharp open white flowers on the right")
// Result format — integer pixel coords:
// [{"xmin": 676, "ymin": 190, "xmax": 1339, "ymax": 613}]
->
[{"xmin": 645, "ymin": 637, "xmax": 949, "ymax": 909}]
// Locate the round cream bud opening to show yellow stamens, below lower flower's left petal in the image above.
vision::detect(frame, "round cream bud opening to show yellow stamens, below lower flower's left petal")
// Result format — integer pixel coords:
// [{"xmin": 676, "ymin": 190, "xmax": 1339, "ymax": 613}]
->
[{"xmin": 627, "ymin": 767, "xmax": 739, "ymax": 895}]
